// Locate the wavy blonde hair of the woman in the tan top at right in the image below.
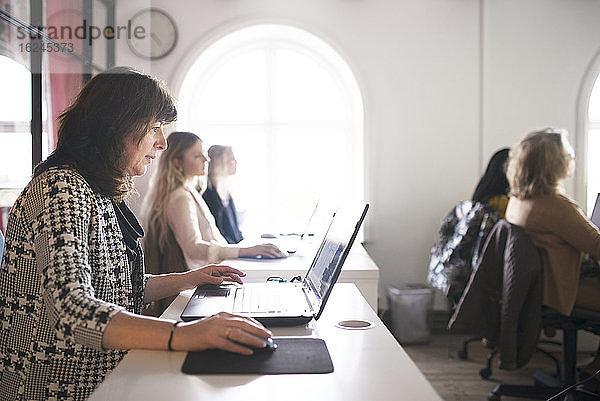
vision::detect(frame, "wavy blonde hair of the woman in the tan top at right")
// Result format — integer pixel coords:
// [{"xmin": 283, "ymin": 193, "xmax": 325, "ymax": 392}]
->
[{"xmin": 506, "ymin": 128, "xmax": 575, "ymax": 199}]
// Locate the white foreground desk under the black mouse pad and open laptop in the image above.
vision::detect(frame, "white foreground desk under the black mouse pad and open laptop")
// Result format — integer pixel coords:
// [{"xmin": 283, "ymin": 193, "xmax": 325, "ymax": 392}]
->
[{"xmin": 90, "ymin": 283, "xmax": 441, "ymax": 401}]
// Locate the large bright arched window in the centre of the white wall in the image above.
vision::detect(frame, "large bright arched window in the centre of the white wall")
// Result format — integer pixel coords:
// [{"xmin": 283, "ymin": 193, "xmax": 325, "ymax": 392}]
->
[{"xmin": 177, "ymin": 24, "xmax": 364, "ymax": 231}]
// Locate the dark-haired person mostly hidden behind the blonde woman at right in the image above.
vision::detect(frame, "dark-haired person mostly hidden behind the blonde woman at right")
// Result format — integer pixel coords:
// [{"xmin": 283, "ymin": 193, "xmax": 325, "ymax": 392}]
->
[{"xmin": 471, "ymin": 148, "xmax": 510, "ymax": 217}]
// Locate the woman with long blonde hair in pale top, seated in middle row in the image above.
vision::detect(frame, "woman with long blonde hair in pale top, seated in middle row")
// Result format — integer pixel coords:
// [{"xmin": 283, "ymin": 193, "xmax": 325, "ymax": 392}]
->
[{"xmin": 145, "ymin": 132, "xmax": 282, "ymax": 273}]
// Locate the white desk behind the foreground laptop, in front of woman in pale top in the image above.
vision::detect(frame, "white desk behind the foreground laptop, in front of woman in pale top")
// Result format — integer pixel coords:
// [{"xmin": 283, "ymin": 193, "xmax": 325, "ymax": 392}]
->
[{"xmin": 223, "ymin": 243, "xmax": 379, "ymax": 311}]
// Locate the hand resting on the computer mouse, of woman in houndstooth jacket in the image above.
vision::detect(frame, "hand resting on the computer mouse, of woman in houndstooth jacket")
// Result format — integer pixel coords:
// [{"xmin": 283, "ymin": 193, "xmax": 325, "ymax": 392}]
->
[{"xmin": 171, "ymin": 312, "xmax": 272, "ymax": 355}]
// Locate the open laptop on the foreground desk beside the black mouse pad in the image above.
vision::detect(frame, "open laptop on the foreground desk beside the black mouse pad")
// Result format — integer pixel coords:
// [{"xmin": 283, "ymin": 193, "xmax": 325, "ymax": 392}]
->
[{"xmin": 181, "ymin": 204, "xmax": 369, "ymax": 326}]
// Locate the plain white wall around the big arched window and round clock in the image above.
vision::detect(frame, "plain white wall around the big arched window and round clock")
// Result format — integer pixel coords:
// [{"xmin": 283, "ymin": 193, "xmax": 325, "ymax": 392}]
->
[{"xmin": 112, "ymin": 0, "xmax": 600, "ymax": 310}]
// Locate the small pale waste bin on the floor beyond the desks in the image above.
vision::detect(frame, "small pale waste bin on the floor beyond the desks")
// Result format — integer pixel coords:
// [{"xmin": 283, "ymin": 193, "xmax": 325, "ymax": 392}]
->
[{"xmin": 388, "ymin": 284, "xmax": 433, "ymax": 344}]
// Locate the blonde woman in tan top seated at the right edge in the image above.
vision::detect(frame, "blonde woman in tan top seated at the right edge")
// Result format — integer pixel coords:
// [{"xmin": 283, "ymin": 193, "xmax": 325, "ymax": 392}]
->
[{"xmin": 506, "ymin": 129, "xmax": 600, "ymax": 315}]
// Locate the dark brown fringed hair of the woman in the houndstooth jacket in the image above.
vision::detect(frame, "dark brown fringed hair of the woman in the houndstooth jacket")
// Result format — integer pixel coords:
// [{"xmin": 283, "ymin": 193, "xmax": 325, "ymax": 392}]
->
[{"xmin": 34, "ymin": 67, "xmax": 177, "ymax": 200}]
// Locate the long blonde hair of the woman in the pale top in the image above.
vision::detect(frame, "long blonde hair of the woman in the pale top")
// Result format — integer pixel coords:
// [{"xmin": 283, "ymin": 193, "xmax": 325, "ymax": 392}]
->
[{"xmin": 144, "ymin": 131, "xmax": 202, "ymax": 247}]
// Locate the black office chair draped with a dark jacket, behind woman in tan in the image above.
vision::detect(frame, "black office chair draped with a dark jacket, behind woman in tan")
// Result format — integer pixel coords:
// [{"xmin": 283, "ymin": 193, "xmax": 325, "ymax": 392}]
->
[{"xmin": 450, "ymin": 220, "xmax": 600, "ymax": 401}]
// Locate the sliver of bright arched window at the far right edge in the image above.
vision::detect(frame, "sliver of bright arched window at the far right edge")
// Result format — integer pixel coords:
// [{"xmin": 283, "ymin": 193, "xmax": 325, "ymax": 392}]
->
[{"xmin": 587, "ymin": 75, "xmax": 600, "ymax": 212}]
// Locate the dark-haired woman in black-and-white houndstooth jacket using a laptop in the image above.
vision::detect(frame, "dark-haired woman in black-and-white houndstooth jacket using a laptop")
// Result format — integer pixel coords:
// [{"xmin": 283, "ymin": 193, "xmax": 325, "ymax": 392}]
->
[{"xmin": 0, "ymin": 67, "xmax": 270, "ymax": 400}]
